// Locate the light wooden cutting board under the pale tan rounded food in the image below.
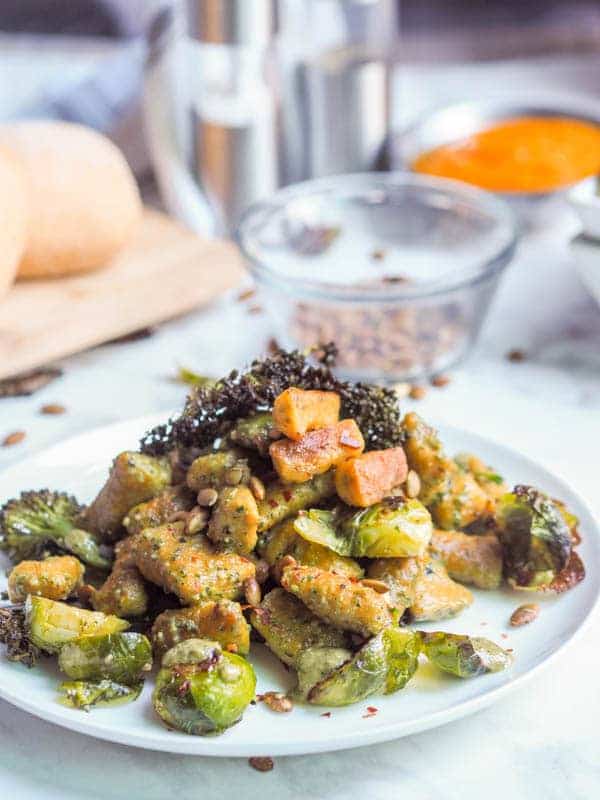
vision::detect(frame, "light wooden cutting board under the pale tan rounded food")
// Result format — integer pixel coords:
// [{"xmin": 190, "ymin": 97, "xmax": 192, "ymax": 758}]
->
[{"xmin": 0, "ymin": 210, "xmax": 243, "ymax": 378}]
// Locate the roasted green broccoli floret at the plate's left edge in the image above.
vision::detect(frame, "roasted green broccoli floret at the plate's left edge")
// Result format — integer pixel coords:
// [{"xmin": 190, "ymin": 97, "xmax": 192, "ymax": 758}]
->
[{"xmin": 0, "ymin": 489, "xmax": 111, "ymax": 569}]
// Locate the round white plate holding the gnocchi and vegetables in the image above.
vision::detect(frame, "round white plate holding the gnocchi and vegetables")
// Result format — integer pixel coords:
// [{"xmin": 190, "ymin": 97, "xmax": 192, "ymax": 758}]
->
[{"xmin": 0, "ymin": 417, "xmax": 600, "ymax": 756}]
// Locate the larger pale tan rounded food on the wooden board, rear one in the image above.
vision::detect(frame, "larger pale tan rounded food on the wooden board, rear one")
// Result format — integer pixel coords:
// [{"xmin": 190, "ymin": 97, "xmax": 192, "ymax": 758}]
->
[{"xmin": 0, "ymin": 121, "xmax": 141, "ymax": 278}]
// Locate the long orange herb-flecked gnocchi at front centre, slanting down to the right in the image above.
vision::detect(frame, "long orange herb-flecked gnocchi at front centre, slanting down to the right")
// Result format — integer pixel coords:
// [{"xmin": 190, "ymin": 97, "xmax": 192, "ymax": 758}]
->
[{"xmin": 281, "ymin": 564, "xmax": 392, "ymax": 636}]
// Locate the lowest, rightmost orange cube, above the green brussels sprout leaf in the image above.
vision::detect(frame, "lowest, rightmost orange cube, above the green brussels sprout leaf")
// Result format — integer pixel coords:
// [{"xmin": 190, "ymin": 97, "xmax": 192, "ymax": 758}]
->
[{"xmin": 335, "ymin": 447, "xmax": 408, "ymax": 508}]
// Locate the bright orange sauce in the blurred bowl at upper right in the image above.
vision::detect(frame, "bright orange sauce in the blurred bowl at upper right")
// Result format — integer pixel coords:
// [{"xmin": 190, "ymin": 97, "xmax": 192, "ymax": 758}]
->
[{"xmin": 413, "ymin": 117, "xmax": 600, "ymax": 192}]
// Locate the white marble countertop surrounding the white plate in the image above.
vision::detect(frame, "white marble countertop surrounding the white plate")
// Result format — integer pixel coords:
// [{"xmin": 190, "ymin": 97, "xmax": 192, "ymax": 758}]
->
[{"xmin": 0, "ymin": 56, "xmax": 600, "ymax": 800}]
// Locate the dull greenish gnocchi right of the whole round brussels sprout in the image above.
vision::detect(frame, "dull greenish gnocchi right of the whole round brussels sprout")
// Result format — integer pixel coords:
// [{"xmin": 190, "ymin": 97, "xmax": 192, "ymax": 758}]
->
[{"xmin": 250, "ymin": 589, "xmax": 350, "ymax": 667}]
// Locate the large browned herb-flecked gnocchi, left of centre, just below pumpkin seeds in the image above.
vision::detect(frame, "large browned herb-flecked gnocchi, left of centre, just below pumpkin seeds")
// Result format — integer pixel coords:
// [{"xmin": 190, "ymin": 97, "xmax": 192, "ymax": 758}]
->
[{"xmin": 131, "ymin": 522, "xmax": 256, "ymax": 604}]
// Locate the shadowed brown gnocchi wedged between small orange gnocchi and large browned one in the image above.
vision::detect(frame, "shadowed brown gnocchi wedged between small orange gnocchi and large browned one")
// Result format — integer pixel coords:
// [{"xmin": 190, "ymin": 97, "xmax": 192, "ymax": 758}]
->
[{"xmin": 90, "ymin": 537, "xmax": 150, "ymax": 618}]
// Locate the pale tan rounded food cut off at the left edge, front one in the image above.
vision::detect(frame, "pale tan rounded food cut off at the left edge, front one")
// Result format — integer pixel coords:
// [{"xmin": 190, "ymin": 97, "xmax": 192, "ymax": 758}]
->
[{"xmin": 0, "ymin": 151, "xmax": 27, "ymax": 298}]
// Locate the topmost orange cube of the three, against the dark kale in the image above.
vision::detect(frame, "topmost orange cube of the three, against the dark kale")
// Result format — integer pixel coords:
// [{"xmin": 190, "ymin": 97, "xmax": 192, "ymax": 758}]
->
[{"xmin": 273, "ymin": 386, "xmax": 341, "ymax": 441}]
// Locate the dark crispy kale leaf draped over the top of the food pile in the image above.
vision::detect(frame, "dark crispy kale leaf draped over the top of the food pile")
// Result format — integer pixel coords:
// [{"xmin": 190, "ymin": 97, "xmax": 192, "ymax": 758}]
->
[{"xmin": 141, "ymin": 344, "xmax": 403, "ymax": 455}]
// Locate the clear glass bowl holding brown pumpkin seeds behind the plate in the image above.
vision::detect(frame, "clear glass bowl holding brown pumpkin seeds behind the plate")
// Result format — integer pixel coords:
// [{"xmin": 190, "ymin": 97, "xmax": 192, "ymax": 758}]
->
[{"xmin": 237, "ymin": 172, "xmax": 516, "ymax": 381}]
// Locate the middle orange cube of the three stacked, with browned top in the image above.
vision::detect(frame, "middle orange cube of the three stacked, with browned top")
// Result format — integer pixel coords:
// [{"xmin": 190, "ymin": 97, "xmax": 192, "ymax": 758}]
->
[{"xmin": 269, "ymin": 419, "xmax": 365, "ymax": 483}]
